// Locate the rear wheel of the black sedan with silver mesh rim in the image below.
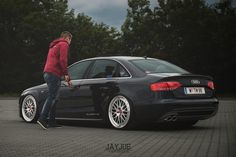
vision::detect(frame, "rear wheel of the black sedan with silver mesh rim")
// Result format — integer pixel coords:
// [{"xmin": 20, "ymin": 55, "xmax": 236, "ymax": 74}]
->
[{"xmin": 107, "ymin": 95, "xmax": 135, "ymax": 129}]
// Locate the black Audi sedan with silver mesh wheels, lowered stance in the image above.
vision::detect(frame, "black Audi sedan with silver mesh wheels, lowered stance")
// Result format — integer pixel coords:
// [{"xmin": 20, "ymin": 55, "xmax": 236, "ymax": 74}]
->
[{"xmin": 19, "ymin": 56, "xmax": 218, "ymax": 129}]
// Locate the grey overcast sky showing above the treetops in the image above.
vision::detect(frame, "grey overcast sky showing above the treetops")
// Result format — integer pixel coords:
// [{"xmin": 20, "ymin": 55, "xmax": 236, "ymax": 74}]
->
[{"xmin": 68, "ymin": 0, "xmax": 233, "ymax": 30}]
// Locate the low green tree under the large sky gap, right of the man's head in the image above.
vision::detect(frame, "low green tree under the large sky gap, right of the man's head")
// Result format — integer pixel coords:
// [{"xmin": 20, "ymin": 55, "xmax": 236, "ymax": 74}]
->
[{"xmin": 72, "ymin": 14, "xmax": 120, "ymax": 61}]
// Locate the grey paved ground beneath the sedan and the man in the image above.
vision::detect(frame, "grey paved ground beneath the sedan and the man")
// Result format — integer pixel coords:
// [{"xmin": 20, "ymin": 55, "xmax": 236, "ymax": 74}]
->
[{"xmin": 0, "ymin": 99, "xmax": 236, "ymax": 157}]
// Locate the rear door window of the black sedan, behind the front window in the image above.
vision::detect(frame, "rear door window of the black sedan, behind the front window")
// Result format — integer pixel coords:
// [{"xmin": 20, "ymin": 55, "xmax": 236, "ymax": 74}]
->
[{"xmin": 89, "ymin": 60, "xmax": 117, "ymax": 78}]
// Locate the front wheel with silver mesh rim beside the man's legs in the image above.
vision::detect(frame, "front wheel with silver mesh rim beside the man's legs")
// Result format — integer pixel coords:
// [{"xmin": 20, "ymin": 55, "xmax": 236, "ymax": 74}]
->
[{"xmin": 20, "ymin": 95, "xmax": 38, "ymax": 123}]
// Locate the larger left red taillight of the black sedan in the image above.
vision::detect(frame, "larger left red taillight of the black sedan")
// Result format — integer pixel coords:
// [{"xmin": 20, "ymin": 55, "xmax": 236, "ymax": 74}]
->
[{"xmin": 150, "ymin": 82, "xmax": 182, "ymax": 92}]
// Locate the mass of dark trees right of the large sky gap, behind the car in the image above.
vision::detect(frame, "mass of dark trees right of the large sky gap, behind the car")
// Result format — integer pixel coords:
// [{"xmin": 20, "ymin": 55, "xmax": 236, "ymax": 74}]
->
[{"xmin": 122, "ymin": 0, "xmax": 236, "ymax": 91}]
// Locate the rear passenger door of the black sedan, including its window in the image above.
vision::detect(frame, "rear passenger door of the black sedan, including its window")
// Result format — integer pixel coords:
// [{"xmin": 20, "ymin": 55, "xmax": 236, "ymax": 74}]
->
[{"xmin": 81, "ymin": 59, "xmax": 118, "ymax": 118}]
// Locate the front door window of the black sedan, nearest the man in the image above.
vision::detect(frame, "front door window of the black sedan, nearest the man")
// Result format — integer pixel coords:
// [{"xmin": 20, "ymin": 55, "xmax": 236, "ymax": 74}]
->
[{"xmin": 68, "ymin": 61, "xmax": 92, "ymax": 80}]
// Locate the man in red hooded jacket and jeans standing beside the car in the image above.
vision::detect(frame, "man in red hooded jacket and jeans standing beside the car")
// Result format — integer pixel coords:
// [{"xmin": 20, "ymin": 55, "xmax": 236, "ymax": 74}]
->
[{"xmin": 37, "ymin": 31, "xmax": 72, "ymax": 129}]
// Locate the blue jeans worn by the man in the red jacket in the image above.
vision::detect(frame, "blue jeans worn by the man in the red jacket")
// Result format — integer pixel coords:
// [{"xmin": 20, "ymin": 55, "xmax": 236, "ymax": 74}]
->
[{"xmin": 39, "ymin": 73, "xmax": 61, "ymax": 123}]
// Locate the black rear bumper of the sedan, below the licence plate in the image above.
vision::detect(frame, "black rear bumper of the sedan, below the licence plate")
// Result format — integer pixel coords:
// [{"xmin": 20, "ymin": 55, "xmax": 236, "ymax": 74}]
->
[{"xmin": 135, "ymin": 98, "xmax": 219, "ymax": 122}]
